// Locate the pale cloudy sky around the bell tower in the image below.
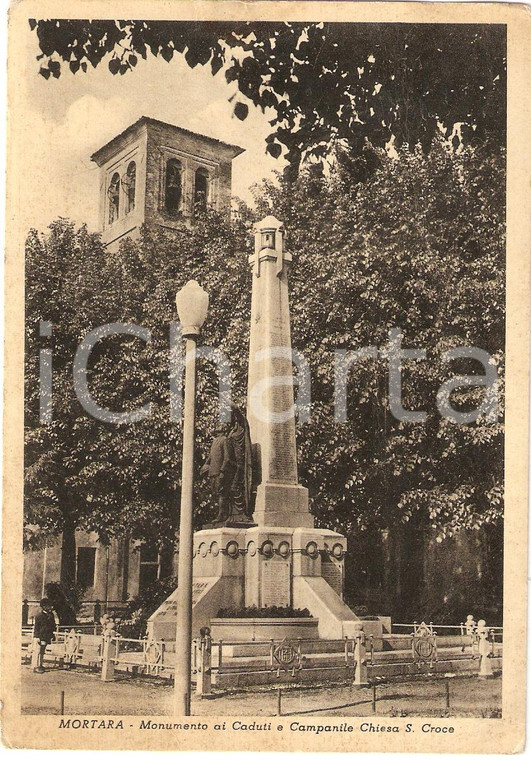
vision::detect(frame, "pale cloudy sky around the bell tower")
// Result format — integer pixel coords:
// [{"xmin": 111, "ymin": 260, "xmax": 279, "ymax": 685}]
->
[{"xmin": 19, "ymin": 27, "xmax": 283, "ymax": 231}]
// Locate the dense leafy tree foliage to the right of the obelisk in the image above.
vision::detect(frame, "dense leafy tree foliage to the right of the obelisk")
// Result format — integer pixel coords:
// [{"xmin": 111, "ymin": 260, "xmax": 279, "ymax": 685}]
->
[{"xmin": 258, "ymin": 142, "xmax": 505, "ymax": 539}]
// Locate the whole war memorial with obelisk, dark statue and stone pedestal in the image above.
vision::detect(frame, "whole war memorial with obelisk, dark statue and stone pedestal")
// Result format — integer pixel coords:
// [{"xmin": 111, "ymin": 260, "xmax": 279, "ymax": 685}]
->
[{"xmin": 148, "ymin": 216, "xmax": 390, "ymax": 642}]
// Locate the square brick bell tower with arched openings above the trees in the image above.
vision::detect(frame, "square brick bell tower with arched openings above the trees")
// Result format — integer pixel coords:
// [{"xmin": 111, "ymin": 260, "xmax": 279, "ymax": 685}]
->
[{"xmin": 91, "ymin": 116, "xmax": 243, "ymax": 246}]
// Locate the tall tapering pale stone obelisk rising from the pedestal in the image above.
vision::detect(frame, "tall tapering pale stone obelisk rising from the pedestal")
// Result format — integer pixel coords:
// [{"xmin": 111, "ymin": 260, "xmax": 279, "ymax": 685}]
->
[{"xmin": 247, "ymin": 216, "xmax": 313, "ymax": 528}]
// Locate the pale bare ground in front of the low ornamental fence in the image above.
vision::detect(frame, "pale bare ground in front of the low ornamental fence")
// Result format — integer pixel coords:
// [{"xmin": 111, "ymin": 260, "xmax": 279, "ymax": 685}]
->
[{"xmin": 21, "ymin": 666, "xmax": 502, "ymax": 718}]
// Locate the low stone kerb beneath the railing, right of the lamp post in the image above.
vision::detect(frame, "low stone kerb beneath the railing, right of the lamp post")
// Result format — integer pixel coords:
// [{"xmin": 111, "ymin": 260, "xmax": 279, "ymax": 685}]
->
[{"xmin": 212, "ymin": 657, "xmax": 502, "ymax": 688}]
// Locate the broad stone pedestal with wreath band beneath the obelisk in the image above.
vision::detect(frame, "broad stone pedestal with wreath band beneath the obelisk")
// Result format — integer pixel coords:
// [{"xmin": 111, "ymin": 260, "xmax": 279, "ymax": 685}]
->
[{"xmin": 148, "ymin": 526, "xmax": 382, "ymax": 642}]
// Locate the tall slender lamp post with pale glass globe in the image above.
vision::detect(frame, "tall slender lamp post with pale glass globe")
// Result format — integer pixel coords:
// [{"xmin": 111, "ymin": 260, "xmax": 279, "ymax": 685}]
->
[{"xmin": 175, "ymin": 280, "xmax": 208, "ymax": 715}]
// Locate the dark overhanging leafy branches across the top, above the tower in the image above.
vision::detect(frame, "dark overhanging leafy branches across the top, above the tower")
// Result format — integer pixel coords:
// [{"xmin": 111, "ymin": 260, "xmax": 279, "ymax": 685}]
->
[{"xmin": 30, "ymin": 19, "xmax": 506, "ymax": 169}]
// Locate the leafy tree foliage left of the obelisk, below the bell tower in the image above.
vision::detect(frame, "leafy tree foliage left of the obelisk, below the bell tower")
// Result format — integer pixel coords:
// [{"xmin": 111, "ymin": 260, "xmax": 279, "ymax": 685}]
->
[{"xmin": 25, "ymin": 213, "xmax": 255, "ymax": 550}]
